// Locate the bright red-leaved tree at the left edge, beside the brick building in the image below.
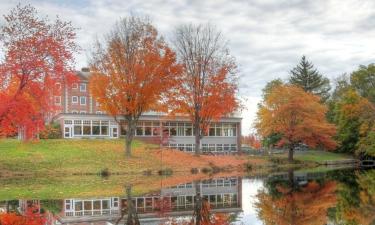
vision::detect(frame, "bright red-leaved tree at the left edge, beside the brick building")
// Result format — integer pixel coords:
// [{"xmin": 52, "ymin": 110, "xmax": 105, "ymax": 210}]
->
[{"xmin": 0, "ymin": 5, "xmax": 78, "ymax": 138}]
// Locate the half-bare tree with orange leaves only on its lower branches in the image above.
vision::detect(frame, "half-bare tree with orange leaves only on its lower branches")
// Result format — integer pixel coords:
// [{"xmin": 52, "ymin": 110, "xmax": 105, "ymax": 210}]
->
[{"xmin": 171, "ymin": 25, "xmax": 239, "ymax": 154}]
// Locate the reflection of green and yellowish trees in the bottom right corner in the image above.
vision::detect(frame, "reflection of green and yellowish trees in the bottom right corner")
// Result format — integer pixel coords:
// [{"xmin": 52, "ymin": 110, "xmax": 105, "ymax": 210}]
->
[{"xmin": 336, "ymin": 170, "xmax": 375, "ymax": 225}]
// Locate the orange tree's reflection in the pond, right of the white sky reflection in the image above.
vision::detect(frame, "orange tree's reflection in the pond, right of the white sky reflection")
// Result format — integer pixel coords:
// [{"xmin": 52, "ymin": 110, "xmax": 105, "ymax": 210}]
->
[{"xmin": 255, "ymin": 172, "xmax": 336, "ymax": 225}]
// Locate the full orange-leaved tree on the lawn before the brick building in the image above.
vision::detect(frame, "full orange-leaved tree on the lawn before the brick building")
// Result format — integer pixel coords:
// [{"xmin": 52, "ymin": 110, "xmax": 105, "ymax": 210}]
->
[{"xmin": 90, "ymin": 17, "xmax": 180, "ymax": 156}]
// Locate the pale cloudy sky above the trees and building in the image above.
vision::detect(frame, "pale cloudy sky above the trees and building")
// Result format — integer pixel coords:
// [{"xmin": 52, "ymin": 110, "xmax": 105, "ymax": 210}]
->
[{"xmin": 0, "ymin": 0, "xmax": 375, "ymax": 134}]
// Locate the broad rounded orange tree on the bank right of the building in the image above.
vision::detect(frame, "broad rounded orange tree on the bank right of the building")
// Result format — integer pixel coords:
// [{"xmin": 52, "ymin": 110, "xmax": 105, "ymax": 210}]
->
[{"xmin": 255, "ymin": 85, "xmax": 336, "ymax": 161}]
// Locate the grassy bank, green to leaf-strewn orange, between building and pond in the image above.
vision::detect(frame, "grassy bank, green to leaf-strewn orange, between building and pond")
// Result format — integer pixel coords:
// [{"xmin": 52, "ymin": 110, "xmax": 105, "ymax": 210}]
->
[{"xmin": 0, "ymin": 139, "xmax": 266, "ymax": 176}]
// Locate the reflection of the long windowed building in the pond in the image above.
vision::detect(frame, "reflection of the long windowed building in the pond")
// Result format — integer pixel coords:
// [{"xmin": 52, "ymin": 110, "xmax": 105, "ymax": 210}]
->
[{"xmin": 56, "ymin": 177, "xmax": 242, "ymax": 224}]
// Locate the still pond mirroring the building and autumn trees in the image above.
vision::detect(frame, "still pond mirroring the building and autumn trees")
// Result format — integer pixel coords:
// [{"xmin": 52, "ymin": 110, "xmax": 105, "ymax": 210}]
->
[{"xmin": 0, "ymin": 168, "xmax": 375, "ymax": 225}]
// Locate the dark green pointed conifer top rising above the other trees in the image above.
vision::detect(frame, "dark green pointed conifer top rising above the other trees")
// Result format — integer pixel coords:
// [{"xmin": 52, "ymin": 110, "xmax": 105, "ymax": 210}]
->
[{"xmin": 289, "ymin": 56, "xmax": 331, "ymax": 101}]
